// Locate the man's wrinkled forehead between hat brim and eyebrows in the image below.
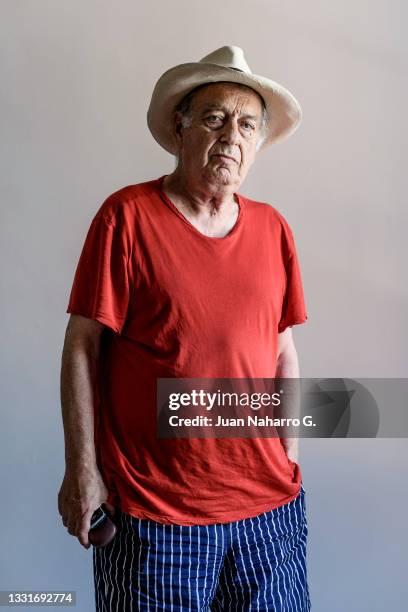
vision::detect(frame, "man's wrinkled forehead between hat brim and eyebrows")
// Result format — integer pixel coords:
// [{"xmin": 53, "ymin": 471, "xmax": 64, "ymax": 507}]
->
[{"xmin": 188, "ymin": 81, "xmax": 264, "ymax": 115}]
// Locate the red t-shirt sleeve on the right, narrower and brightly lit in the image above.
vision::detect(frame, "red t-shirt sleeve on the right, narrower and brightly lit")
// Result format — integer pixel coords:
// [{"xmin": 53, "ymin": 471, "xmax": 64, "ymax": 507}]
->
[{"xmin": 278, "ymin": 228, "xmax": 307, "ymax": 334}]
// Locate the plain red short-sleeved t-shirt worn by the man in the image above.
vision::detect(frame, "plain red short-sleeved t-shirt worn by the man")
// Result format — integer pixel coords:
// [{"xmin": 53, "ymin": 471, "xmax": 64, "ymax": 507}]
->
[{"xmin": 67, "ymin": 176, "xmax": 307, "ymax": 525}]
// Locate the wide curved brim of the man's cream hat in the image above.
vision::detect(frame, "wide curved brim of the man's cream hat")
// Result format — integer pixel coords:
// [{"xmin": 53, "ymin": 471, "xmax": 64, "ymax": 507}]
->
[{"xmin": 147, "ymin": 62, "xmax": 302, "ymax": 155}]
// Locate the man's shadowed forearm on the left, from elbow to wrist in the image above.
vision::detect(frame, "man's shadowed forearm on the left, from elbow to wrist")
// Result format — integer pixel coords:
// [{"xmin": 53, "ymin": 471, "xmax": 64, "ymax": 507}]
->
[{"xmin": 61, "ymin": 344, "xmax": 98, "ymax": 470}]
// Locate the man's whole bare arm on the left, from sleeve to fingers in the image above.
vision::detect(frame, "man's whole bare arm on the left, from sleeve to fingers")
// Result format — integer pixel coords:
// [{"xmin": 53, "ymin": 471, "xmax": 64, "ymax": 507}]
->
[{"xmin": 58, "ymin": 315, "xmax": 113, "ymax": 548}]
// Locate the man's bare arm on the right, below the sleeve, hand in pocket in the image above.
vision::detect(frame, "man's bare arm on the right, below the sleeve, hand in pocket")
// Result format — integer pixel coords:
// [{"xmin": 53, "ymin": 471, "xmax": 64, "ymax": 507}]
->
[{"xmin": 275, "ymin": 327, "xmax": 299, "ymax": 463}]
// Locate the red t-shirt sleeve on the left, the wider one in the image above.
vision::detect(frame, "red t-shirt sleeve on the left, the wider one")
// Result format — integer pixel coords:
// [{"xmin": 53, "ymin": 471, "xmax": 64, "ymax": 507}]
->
[{"xmin": 66, "ymin": 214, "xmax": 130, "ymax": 334}]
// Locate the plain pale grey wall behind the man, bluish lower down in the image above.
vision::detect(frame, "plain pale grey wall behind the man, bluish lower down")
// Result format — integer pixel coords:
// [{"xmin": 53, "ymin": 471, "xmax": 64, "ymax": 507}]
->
[{"xmin": 0, "ymin": 0, "xmax": 408, "ymax": 612}]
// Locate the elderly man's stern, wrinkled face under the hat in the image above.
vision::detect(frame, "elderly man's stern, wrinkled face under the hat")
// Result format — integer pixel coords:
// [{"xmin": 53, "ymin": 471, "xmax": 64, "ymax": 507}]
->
[{"xmin": 177, "ymin": 83, "xmax": 262, "ymax": 188}]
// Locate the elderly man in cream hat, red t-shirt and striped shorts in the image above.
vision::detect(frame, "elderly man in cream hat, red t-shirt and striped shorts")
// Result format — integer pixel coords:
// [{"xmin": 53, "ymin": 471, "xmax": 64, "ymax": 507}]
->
[{"xmin": 58, "ymin": 47, "xmax": 310, "ymax": 612}]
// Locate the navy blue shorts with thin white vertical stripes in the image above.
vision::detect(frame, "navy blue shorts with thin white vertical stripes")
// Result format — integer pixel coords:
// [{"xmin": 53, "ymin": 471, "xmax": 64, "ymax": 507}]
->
[{"xmin": 93, "ymin": 484, "xmax": 310, "ymax": 612}]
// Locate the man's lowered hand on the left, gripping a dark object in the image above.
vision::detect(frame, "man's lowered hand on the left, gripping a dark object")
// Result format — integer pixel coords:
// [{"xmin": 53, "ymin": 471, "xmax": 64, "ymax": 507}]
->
[{"xmin": 58, "ymin": 467, "xmax": 115, "ymax": 549}]
